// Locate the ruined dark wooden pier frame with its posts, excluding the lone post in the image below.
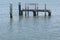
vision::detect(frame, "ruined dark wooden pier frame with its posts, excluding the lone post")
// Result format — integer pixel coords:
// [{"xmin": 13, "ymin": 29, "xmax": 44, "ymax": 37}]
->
[{"xmin": 19, "ymin": 3, "xmax": 51, "ymax": 16}]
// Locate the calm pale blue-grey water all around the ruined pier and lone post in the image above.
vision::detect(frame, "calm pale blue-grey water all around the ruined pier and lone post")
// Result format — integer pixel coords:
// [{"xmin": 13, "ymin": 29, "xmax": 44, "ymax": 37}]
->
[{"xmin": 0, "ymin": 0, "xmax": 60, "ymax": 40}]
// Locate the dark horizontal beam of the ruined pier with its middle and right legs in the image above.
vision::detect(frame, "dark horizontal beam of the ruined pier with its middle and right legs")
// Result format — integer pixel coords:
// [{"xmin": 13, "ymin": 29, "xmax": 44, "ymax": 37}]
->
[{"xmin": 21, "ymin": 9, "xmax": 51, "ymax": 16}]
